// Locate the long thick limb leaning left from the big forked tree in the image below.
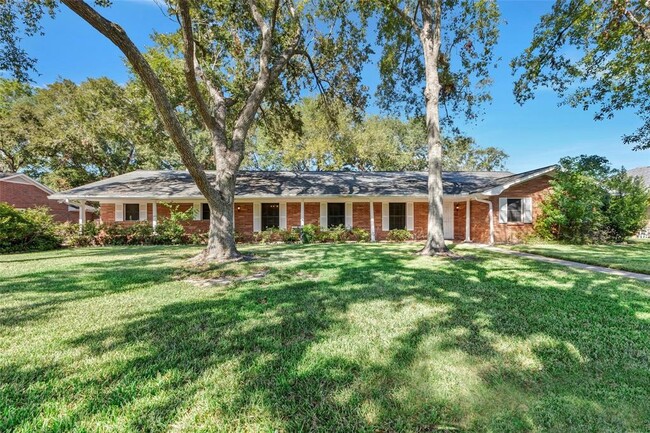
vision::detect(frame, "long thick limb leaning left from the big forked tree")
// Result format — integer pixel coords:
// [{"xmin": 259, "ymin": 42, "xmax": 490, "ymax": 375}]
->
[{"xmin": 61, "ymin": 0, "xmax": 216, "ymax": 199}]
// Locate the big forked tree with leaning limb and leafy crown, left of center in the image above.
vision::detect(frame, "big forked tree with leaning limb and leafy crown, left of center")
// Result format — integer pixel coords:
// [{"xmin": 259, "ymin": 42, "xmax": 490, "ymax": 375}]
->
[{"xmin": 0, "ymin": 0, "xmax": 368, "ymax": 260}]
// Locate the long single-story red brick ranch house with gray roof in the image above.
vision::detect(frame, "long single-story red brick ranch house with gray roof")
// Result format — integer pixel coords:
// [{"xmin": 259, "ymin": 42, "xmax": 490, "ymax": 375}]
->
[{"xmin": 50, "ymin": 166, "xmax": 555, "ymax": 243}]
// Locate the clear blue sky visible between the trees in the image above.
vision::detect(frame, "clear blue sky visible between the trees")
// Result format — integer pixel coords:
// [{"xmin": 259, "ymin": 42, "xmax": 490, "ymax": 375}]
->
[{"xmin": 20, "ymin": 0, "xmax": 650, "ymax": 171}]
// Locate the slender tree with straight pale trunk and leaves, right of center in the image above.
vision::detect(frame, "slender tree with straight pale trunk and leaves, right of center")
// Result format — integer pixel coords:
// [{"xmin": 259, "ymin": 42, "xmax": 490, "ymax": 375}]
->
[{"xmin": 363, "ymin": 0, "xmax": 499, "ymax": 254}]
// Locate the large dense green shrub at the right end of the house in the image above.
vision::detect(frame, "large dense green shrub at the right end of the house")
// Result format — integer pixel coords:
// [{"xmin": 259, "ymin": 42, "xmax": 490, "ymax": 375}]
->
[{"xmin": 535, "ymin": 155, "xmax": 650, "ymax": 244}]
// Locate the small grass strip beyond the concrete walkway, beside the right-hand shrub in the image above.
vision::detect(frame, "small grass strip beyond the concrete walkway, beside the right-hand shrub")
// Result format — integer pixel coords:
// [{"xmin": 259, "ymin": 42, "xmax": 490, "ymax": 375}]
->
[{"xmin": 511, "ymin": 240, "xmax": 650, "ymax": 274}]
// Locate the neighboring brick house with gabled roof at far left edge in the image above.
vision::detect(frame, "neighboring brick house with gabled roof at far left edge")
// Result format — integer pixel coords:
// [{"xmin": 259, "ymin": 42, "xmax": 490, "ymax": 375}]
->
[{"xmin": 0, "ymin": 172, "xmax": 94, "ymax": 222}]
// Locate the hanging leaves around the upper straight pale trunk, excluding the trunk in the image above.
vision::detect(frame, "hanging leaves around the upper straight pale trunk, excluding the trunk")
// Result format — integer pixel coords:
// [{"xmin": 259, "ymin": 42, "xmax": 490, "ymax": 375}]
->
[{"xmin": 365, "ymin": 0, "xmax": 500, "ymax": 125}]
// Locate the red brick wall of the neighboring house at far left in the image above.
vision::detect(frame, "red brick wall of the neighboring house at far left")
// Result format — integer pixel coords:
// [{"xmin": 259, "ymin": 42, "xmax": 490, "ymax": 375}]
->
[{"xmin": 0, "ymin": 181, "xmax": 94, "ymax": 222}]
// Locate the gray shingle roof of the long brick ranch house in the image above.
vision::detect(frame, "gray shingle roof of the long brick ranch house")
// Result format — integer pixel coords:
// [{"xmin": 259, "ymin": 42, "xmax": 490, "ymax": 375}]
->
[{"xmin": 50, "ymin": 167, "xmax": 548, "ymax": 200}]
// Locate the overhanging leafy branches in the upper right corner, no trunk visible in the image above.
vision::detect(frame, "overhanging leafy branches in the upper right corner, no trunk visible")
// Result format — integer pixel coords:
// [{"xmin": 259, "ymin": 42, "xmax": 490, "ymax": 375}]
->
[{"xmin": 512, "ymin": 0, "xmax": 650, "ymax": 150}]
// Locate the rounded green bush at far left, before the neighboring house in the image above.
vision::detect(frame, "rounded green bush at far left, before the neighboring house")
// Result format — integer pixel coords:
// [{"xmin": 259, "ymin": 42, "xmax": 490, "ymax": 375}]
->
[{"xmin": 0, "ymin": 202, "xmax": 61, "ymax": 253}]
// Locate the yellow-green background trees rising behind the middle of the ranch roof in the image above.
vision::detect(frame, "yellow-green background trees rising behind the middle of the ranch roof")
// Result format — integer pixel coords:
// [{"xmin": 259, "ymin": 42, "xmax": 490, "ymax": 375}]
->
[{"xmin": 243, "ymin": 98, "xmax": 507, "ymax": 171}]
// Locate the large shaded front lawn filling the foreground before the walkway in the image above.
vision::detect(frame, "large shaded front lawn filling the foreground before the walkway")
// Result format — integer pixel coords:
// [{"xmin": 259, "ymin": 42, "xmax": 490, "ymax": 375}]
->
[{"xmin": 0, "ymin": 244, "xmax": 650, "ymax": 433}]
